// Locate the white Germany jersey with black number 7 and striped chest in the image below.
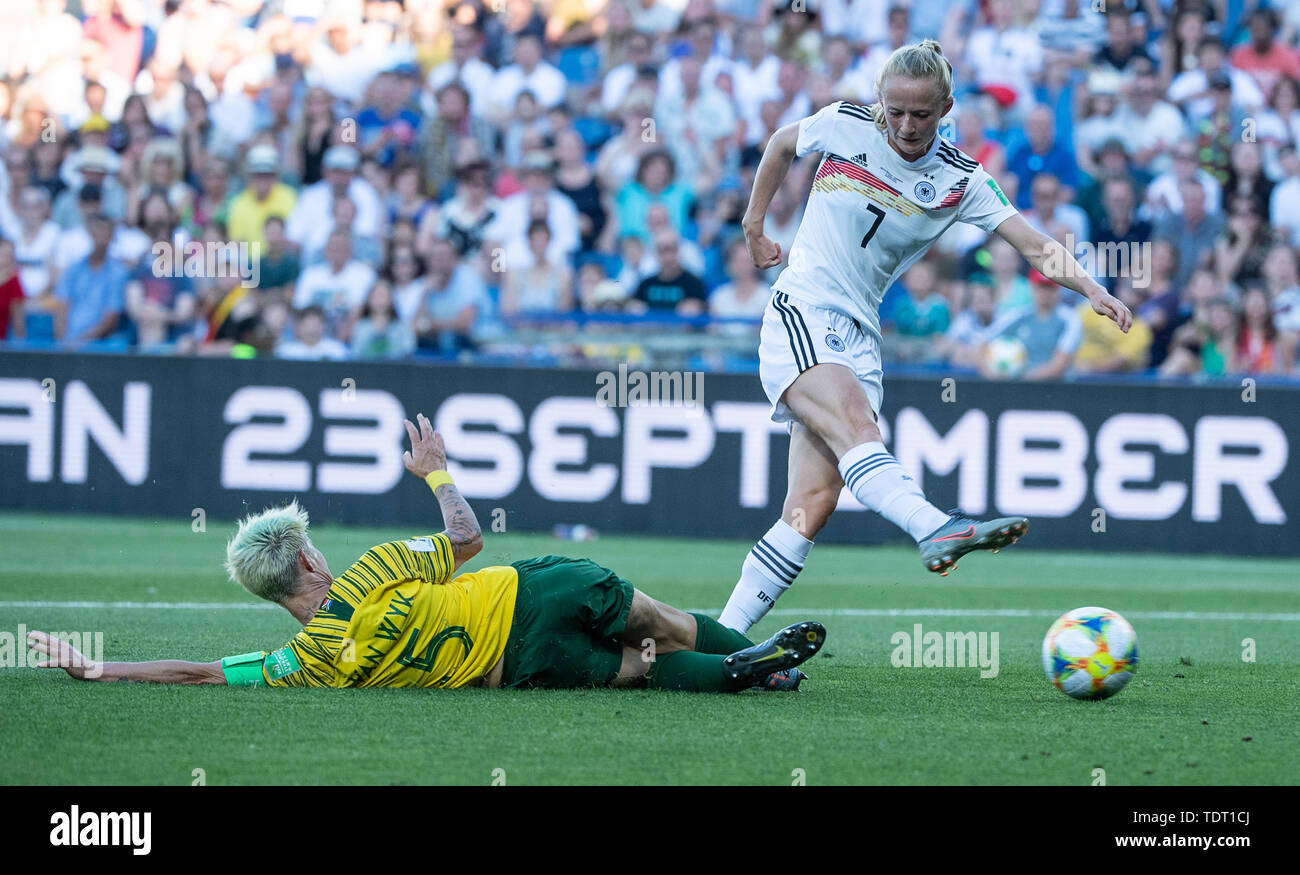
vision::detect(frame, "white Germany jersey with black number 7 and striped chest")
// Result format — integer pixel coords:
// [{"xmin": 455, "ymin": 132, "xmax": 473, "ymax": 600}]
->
[{"xmin": 772, "ymin": 101, "xmax": 1017, "ymax": 338}]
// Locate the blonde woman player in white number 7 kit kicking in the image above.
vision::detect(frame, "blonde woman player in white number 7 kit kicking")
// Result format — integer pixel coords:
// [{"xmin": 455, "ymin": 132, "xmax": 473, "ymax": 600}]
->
[{"xmin": 722, "ymin": 40, "xmax": 1132, "ymax": 632}]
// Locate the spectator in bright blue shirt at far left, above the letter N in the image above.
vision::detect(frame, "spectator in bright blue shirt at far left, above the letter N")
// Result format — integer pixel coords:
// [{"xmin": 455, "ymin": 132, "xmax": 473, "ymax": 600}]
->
[{"xmin": 55, "ymin": 212, "xmax": 127, "ymax": 346}]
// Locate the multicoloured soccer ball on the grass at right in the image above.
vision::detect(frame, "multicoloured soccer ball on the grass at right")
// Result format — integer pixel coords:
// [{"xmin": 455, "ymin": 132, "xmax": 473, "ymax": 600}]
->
[{"xmin": 1043, "ymin": 607, "xmax": 1138, "ymax": 698}]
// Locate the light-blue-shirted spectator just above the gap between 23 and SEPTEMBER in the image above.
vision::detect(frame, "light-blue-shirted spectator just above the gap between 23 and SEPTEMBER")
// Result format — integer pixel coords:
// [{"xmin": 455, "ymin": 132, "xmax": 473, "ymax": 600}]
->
[{"xmin": 415, "ymin": 239, "xmax": 489, "ymax": 355}]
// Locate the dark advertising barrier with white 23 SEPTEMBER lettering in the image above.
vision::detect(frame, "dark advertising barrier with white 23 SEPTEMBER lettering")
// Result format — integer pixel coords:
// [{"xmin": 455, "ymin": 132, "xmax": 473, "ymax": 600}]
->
[{"xmin": 0, "ymin": 352, "xmax": 1300, "ymax": 563}]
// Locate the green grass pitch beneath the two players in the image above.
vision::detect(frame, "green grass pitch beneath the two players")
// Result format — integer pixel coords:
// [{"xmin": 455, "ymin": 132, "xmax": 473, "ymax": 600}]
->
[{"xmin": 0, "ymin": 514, "xmax": 1300, "ymax": 785}]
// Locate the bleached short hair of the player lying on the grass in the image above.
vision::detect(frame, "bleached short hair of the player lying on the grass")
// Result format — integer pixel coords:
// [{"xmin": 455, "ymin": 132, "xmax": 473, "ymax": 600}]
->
[{"xmin": 226, "ymin": 499, "xmax": 307, "ymax": 605}]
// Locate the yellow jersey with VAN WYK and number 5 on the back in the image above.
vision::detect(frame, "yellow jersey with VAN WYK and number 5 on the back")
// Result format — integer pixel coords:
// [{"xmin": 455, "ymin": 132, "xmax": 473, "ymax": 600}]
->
[{"xmin": 261, "ymin": 533, "xmax": 519, "ymax": 688}]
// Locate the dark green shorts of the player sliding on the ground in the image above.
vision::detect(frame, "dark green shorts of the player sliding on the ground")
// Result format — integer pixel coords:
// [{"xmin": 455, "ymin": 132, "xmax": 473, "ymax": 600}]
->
[{"xmin": 501, "ymin": 556, "xmax": 633, "ymax": 689}]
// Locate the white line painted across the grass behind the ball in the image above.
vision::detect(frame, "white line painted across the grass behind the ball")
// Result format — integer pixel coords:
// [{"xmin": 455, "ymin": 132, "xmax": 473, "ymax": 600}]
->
[{"xmin": 0, "ymin": 601, "xmax": 1300, "ymax": 623}]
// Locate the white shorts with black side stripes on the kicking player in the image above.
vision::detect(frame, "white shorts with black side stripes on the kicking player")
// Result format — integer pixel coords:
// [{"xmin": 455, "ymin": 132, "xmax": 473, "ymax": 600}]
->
[{"xmin": 758, "ymin": 290, "xmax": 885, "ymax": 423}]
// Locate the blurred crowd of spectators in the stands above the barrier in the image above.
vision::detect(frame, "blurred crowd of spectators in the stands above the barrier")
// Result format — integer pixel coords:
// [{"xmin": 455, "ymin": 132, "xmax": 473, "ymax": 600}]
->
[{"xmin": 0, "ymin": 0, "xmax": 1300, "ymax": 378}]
